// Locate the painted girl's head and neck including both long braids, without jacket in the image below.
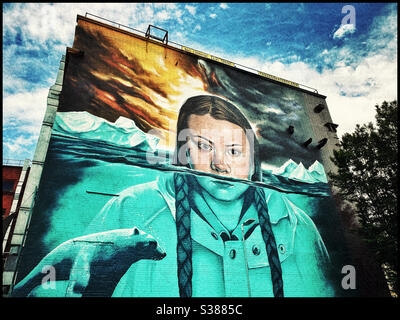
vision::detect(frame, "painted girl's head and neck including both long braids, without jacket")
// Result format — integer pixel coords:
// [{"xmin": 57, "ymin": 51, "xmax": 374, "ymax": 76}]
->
[{"xmin": 174, "ymin": 95, "xmax": 283, "ymax": 296}]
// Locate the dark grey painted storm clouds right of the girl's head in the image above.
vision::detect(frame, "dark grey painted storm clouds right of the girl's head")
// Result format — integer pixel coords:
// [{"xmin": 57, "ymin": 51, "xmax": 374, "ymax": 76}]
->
[{"xmin": 198, "ymin": 59, "xmax": 319, "ymax": 166}]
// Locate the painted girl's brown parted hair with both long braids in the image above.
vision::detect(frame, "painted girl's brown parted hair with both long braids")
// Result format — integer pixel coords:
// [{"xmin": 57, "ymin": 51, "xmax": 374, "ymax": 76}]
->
[{"xmin": 174, "ymin": 95, "xmax": 283, "ymax": 297}]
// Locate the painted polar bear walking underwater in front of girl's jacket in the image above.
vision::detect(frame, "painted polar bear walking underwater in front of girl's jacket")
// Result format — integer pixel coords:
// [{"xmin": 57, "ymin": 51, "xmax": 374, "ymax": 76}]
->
[{"xmin": 12, "ymin": 227, "xmax": 166, "ymax": 297}]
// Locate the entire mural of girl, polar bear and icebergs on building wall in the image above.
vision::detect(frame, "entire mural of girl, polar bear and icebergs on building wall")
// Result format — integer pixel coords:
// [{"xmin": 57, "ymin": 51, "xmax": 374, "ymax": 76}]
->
[{"xmin": 13, "ymin": 19, "xmax": 348, "ymax": 297}]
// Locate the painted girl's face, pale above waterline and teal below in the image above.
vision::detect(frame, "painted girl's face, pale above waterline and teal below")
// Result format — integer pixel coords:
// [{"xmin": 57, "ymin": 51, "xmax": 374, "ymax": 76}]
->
[{"xmin": 187, "ymin": 114, "xmax": 253, "ymax": 201}]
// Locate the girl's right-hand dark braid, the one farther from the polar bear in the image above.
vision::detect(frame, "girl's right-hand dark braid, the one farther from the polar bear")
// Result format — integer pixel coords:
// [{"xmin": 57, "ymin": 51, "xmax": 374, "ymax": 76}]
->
[{"xmin": 254, "ymin": 188, "xmax": 283, "ymax": 297}]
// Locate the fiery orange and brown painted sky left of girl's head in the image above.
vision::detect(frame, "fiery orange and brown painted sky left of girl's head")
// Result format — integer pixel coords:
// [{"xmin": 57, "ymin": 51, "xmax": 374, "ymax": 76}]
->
[{"xmin": 61, "ymin": 20, "xmax": 218, "ymax": 147}]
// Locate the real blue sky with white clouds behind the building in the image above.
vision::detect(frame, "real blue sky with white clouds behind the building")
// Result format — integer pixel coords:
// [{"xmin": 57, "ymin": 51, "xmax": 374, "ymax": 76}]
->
[{"xmin": 3, "ymin": 3, "xmax": 397, "ymax": 159}]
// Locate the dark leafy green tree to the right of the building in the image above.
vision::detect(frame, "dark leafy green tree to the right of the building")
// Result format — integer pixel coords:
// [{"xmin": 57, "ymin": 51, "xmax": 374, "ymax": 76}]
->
[{"xmin": 329, "ymin": 100, "xmax": 398, "ymax": 296}]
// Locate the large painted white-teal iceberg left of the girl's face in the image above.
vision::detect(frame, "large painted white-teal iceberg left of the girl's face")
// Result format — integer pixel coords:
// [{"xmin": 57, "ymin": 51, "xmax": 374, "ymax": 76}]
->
[{"xmin": 53, "ymin": 111, "xmax": 159, "ymax": 151}]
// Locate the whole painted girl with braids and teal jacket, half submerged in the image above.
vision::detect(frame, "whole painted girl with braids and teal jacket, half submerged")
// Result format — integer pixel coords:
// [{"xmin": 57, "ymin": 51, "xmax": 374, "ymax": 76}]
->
[{"xmin": 11, "ymin": 95, "xmax": 334, "ymax": 297}]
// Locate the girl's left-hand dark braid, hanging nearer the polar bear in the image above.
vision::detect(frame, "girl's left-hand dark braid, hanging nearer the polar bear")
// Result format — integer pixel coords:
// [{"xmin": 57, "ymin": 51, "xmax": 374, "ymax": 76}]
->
[{"xmin": 174, "ymin": 173, "xmax": 193, "ymax": 297}]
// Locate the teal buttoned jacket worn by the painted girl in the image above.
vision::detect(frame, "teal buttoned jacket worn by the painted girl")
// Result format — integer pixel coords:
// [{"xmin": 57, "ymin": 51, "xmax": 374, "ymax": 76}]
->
[{"xmin": 86, "ymin": 176, "xmax": 334, "ymax": 297}]
